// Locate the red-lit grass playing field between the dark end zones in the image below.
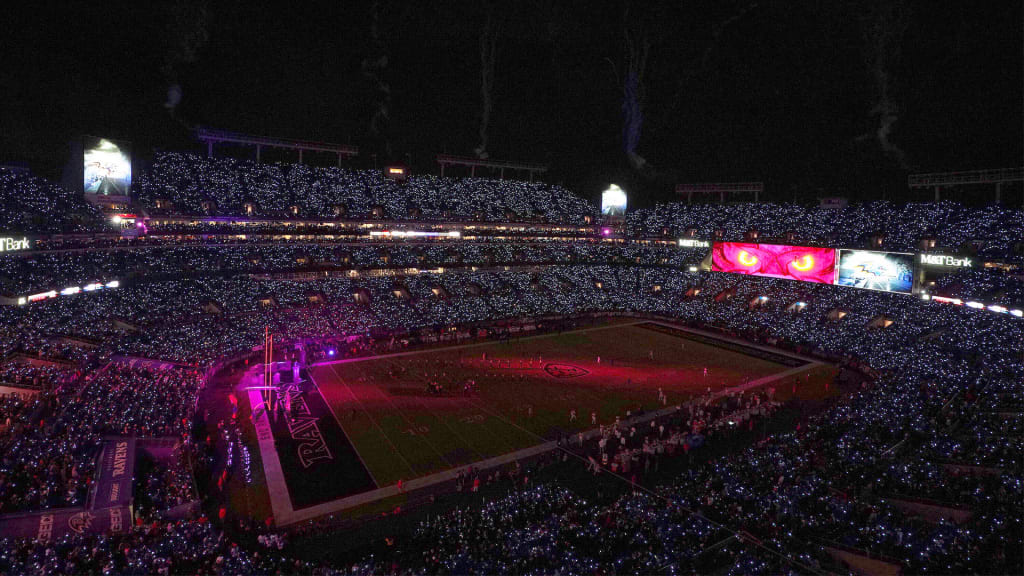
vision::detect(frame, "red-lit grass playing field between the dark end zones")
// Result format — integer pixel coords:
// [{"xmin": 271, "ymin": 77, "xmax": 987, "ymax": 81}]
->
[{"xmin": 310, "ymin": 319, "xmax": 806, "ymax": 486}]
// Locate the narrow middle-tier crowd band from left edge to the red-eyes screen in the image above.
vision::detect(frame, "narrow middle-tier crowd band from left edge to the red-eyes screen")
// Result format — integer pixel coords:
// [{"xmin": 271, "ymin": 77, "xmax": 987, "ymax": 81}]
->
[{"xmin": 0, "ymin": 241, "xmax": 702, "ymax": 294}]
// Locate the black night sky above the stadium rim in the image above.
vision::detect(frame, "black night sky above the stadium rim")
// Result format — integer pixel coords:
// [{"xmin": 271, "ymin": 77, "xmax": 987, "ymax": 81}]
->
[{"xmin": 0, "ymin": 0, "xmax": 1024, "ymax": 205}]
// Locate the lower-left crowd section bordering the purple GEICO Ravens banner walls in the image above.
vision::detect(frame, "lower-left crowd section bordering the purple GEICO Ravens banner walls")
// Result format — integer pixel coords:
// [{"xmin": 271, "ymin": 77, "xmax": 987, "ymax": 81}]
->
[{"xmin": 0, "ymin": 363, "xmax": 201, "ymax": 512}]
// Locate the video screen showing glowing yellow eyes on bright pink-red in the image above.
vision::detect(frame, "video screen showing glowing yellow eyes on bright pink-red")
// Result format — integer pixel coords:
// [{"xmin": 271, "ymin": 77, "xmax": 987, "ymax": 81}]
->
[{"xmin": 711, "ymin": 242, "xmax": 836, "ymax": 284}]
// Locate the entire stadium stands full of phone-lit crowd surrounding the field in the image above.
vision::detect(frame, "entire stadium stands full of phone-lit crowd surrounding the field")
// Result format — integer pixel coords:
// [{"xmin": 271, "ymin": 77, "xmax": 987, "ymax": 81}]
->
[{"xmin": 0, "ymin": 157, "xmax": 1024, "ymax": 574}]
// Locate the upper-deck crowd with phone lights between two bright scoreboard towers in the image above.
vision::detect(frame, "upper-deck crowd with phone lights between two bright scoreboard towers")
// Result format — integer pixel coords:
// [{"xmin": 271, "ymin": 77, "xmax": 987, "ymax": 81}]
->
[{"xmin": 137, "ymin": 153, "xmax": 596, "ymax": 223}]
